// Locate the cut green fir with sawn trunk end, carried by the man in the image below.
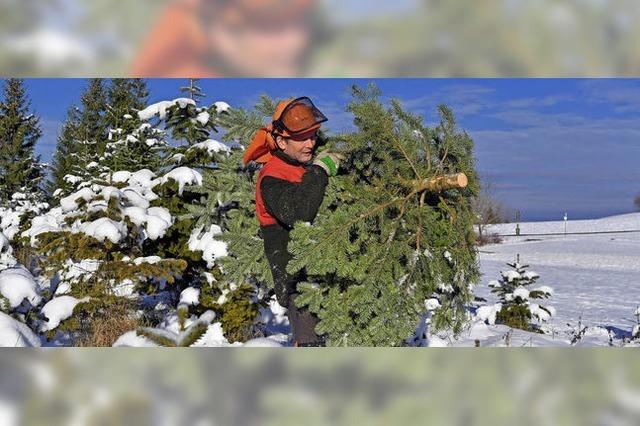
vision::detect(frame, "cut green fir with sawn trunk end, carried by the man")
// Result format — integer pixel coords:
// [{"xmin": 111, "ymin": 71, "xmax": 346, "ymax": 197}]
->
[{"xmin": 288, "ymin": 86, "xmax": 478, "ymax": 346}]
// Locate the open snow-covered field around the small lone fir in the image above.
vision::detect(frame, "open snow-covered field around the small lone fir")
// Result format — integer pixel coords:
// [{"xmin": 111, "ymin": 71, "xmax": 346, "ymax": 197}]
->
[{"xmin": 454, "ymin": 213, "xmax": 640, "ymax": 346}]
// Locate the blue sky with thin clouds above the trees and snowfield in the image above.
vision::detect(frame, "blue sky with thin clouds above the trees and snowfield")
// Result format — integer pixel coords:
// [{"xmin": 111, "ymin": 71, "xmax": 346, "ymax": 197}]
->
[{"xmin": 13, "ymin": 79, "xmax": 640, "ymax": 220}]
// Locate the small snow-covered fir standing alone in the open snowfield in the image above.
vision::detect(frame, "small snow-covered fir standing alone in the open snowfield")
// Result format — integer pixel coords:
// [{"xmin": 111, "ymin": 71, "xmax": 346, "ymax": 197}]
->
[{"xmin": 484, "ymin": 255, "xmax": 555, "ymax": 331}]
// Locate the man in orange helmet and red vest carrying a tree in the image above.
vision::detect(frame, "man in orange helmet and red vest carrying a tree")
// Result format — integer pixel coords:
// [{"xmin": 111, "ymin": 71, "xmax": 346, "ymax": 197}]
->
[{"xmin": 244, "ymin": 97, "xmax": 341, "ymax": 346}]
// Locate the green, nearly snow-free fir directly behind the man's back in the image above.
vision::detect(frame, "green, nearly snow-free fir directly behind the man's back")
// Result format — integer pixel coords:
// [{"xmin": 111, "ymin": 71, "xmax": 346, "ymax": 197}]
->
[{"xmin": 181, "ymin": 97, "xmax": 275, "ymax": 341}]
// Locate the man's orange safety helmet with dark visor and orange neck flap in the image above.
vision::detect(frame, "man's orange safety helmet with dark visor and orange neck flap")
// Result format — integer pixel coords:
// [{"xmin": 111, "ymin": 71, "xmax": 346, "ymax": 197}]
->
[{"xmin": 242, "ymin": 96, "xmax": 328, "ymax": 165}]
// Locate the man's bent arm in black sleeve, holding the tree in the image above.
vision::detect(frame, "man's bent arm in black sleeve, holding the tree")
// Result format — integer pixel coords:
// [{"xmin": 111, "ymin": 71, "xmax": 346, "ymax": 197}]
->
[{"xmin": 260, "ymin": 166, "xmax": 329, "ymax": 226}]
